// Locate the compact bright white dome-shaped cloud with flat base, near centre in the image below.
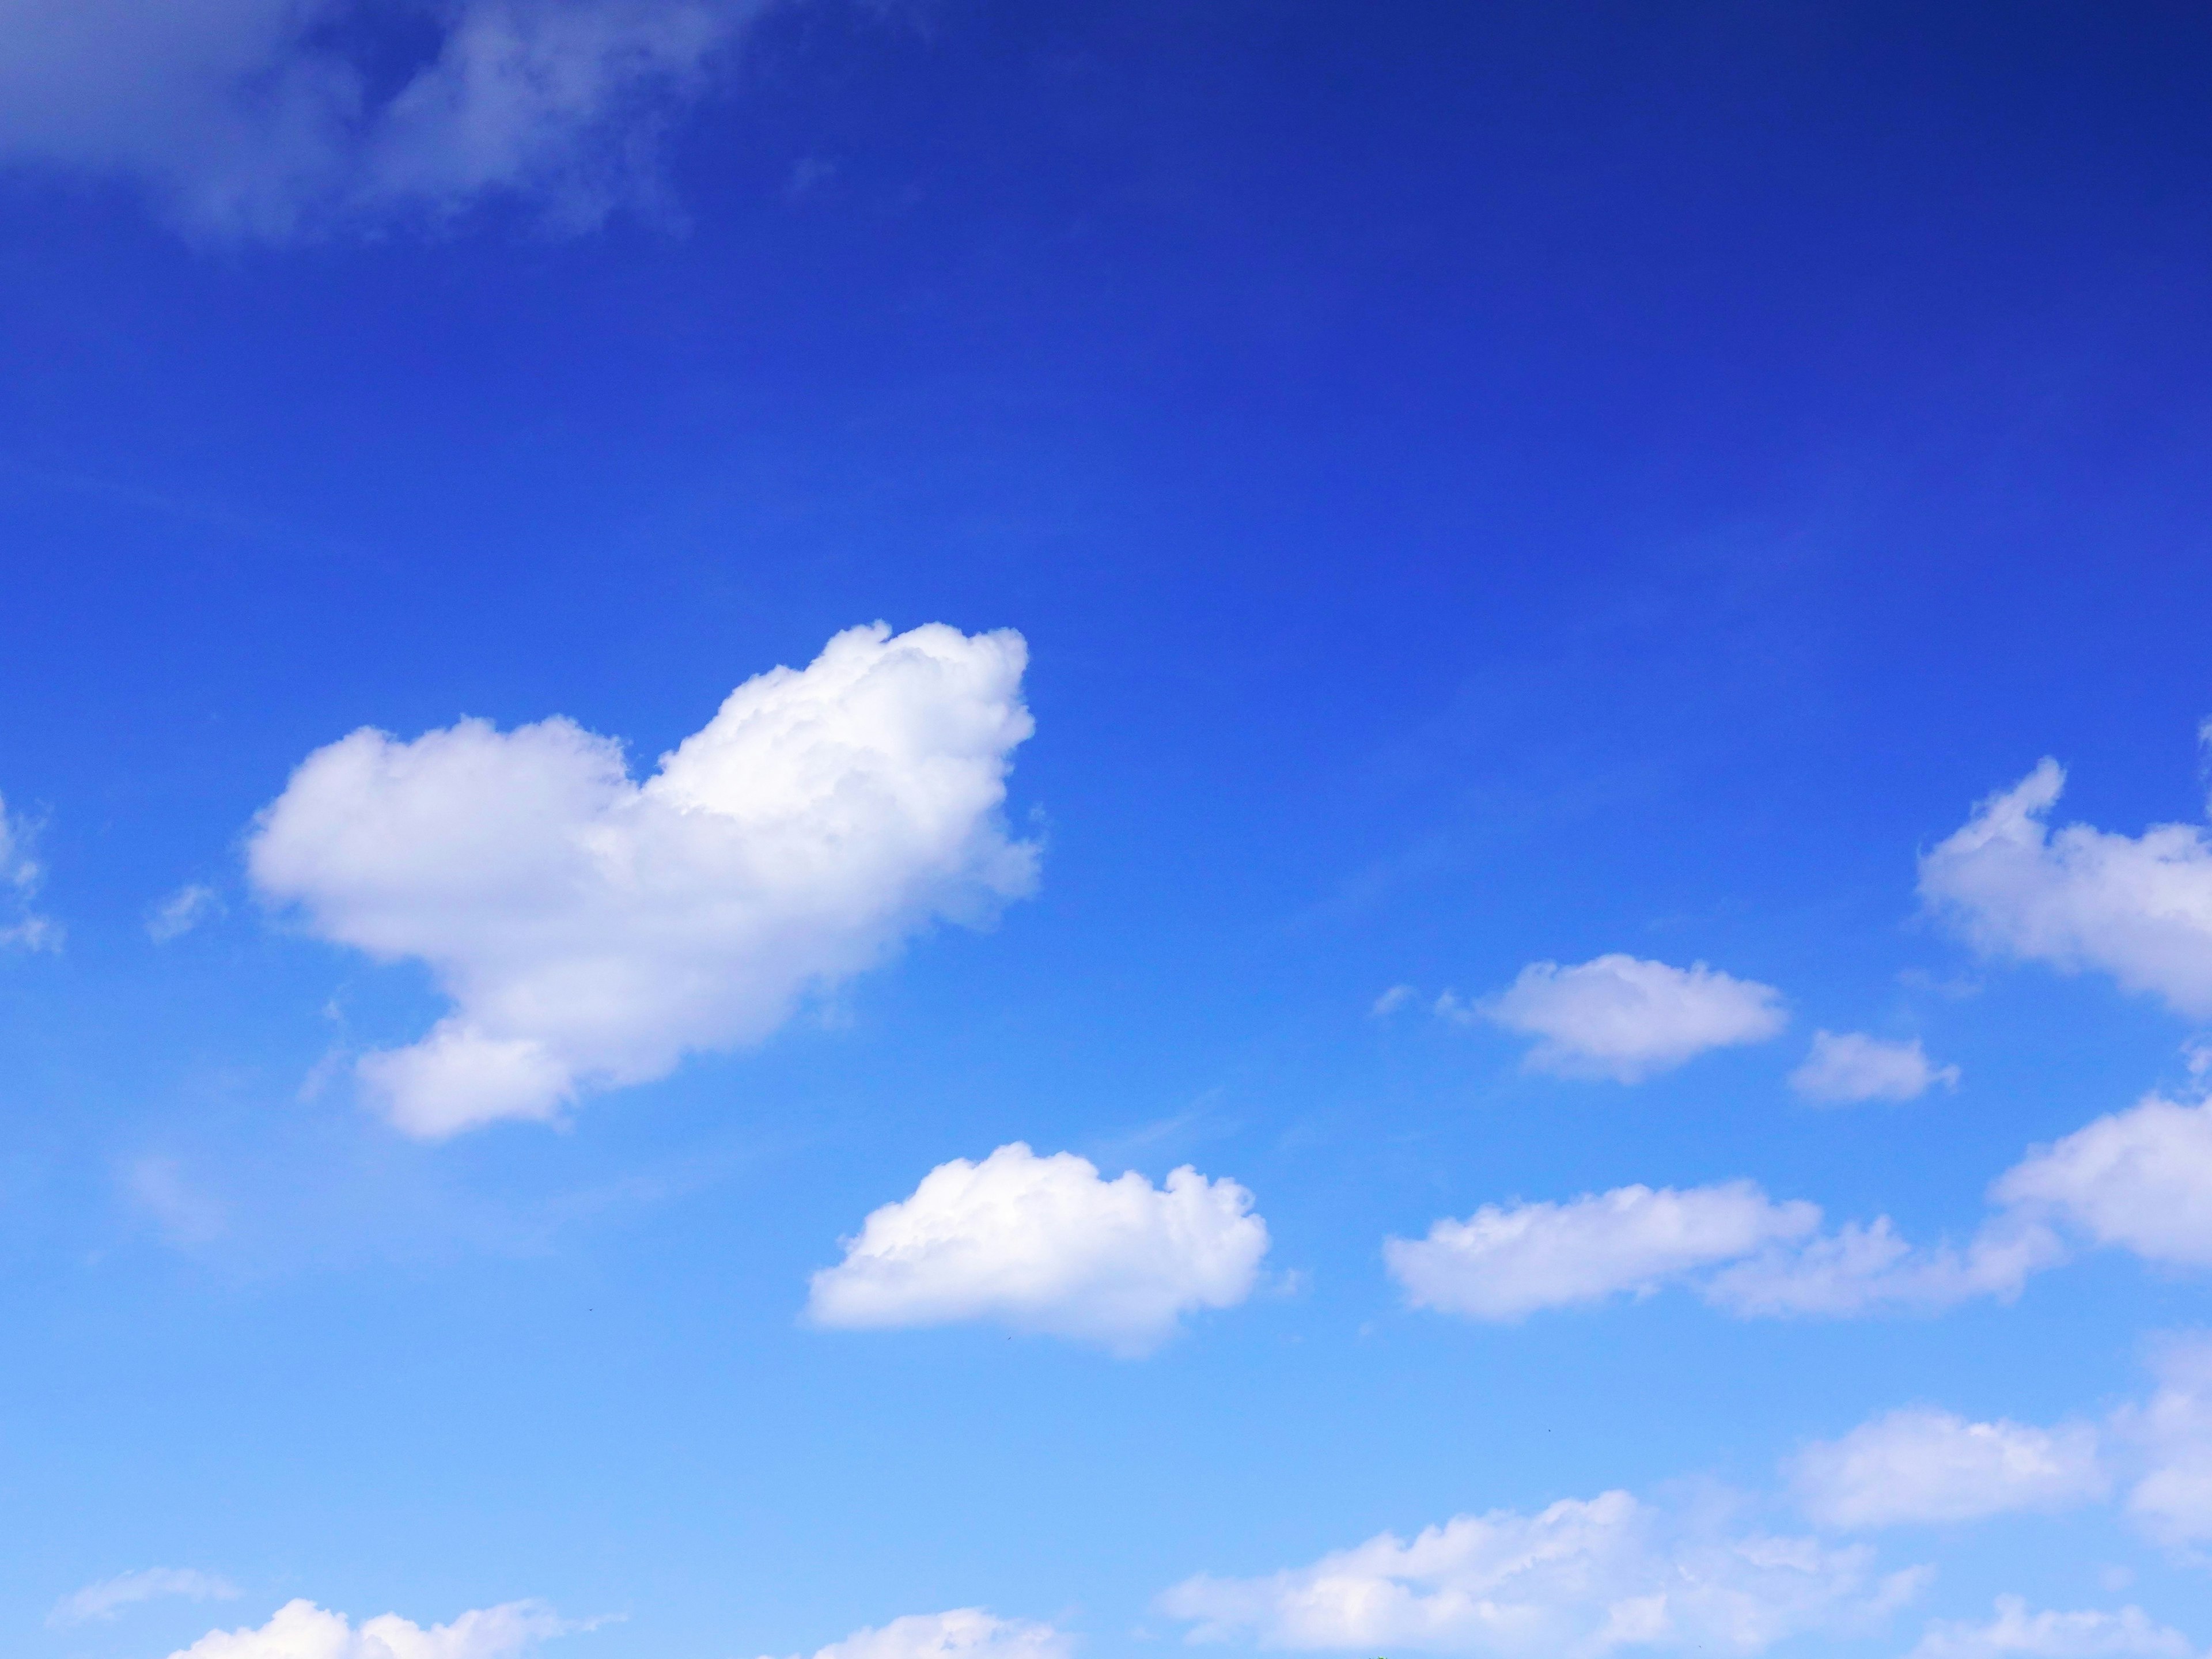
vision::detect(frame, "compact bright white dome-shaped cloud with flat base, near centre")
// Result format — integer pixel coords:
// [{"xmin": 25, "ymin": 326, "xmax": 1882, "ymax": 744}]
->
[{"xmin": 808, "ymin": 1141, "xmax": 1267, "ymax": 1356}]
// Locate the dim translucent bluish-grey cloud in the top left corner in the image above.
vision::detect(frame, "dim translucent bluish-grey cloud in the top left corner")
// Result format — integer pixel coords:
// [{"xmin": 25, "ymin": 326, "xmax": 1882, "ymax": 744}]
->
[{"xmin": 0, "ymin": 0, "xmax": 787, "ymax": 237}]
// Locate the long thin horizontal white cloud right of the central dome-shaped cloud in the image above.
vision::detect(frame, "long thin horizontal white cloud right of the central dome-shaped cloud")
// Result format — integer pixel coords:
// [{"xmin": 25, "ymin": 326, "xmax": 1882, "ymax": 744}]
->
[{"xmin": 1382, "ymin": 1181, "xmax": 2064, "ymax": 1320}]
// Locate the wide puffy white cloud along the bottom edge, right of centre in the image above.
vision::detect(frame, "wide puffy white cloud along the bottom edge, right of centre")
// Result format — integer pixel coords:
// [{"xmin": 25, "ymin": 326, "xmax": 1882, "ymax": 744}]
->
[{"xmin": 1159, "ymin": 1491, "xmax": 1922, "ymax": 1659}]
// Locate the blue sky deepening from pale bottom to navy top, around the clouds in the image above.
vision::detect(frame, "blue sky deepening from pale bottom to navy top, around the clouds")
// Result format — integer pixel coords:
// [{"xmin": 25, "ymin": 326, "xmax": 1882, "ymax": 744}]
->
[{"xmin": 0, "ymin": 0, "xmax": 2212, "ymax": 1659}]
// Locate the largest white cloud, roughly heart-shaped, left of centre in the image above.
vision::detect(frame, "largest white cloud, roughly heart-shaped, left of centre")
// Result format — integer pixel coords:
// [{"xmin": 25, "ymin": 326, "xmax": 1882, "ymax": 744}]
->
[{"xmin": 248, "ymin": 624, "xmax": 1037, "ymax": 1135}]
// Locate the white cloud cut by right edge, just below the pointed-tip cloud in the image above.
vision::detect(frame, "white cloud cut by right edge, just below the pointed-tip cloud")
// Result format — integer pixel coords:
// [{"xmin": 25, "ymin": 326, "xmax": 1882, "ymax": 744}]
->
[{"xmin": 1991, "ymin": 1095, "xmax": 2212, "ymax": 1267}]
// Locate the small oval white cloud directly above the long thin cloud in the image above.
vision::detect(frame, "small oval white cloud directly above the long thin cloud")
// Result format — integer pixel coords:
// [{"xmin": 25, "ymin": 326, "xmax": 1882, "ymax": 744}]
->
[{"xmin": 1478, "ymin": 953, "xmax": 1785, "ymax": 1084}]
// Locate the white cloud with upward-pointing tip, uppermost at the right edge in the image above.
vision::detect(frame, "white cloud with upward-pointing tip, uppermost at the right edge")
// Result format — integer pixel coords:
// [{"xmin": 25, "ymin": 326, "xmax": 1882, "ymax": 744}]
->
[{"xmin": 1920, "ymin": 759, "xmax": 2212, "ymax": 1017}]
